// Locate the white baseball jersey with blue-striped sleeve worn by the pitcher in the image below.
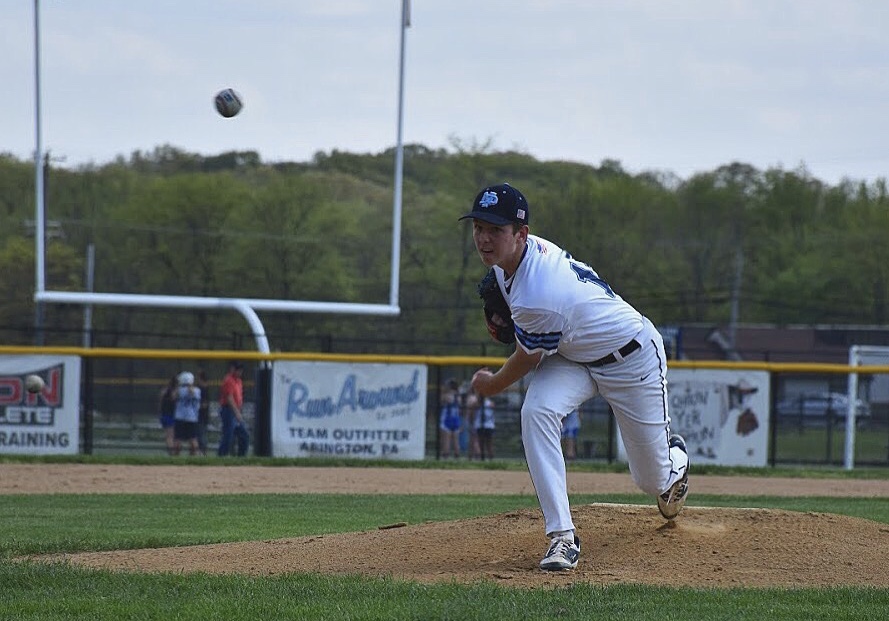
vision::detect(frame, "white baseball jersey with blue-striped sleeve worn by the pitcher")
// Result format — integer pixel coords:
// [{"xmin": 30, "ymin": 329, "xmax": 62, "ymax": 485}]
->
[{"xmin": 494, "ymin": 235, "xmax": 642, "ymax": 363}]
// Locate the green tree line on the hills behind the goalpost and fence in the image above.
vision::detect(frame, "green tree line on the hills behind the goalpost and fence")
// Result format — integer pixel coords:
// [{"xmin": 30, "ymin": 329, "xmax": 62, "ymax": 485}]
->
[{"xmin": 0, "ymin": 144, "xmax": 889, "ymax": 355}]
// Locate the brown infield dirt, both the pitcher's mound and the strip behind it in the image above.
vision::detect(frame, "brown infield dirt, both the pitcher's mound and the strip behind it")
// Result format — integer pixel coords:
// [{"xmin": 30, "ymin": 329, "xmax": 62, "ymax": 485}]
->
[{"xmin": 6, "ymin": 464, "xmax": 889, "ymax": 587}]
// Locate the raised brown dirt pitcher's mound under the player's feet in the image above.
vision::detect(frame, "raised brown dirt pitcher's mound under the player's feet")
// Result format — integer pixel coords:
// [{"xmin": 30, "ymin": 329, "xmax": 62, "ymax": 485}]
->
[{"xmin": 46, "ymin": 504, "xmax": 889, "ymax": 587}]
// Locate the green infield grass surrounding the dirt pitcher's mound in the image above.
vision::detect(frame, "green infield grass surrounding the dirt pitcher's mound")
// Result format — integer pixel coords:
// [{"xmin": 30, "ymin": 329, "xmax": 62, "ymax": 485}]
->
[{"xmin": 0, "ymin": 464, "xmax": 889, "ymax": 621}]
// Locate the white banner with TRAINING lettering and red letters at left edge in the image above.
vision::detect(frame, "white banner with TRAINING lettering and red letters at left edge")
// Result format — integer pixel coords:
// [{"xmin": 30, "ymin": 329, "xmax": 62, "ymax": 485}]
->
[{"xmin": 0, "ymin": 355, "xmax": 80, "ymax": 455}]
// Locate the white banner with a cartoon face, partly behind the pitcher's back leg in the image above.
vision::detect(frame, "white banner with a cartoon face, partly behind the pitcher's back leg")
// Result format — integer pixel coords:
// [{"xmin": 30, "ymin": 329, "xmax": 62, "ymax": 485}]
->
[{"xmin": 618, "ymin": 369, "xmax": 769, "ymax": 468}]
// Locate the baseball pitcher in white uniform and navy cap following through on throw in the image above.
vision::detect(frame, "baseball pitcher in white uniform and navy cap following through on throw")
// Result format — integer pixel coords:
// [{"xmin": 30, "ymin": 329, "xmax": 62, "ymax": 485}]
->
[{"xmin": 460, "ymin": 184, "xmax": 688, "ymax": 570}]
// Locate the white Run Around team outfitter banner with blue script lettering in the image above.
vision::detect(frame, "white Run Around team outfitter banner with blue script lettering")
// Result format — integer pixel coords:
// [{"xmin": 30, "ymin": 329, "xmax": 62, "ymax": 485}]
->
[{"xmin": 272, "ymin": 361, "xmax": 427, "ymax": 459}]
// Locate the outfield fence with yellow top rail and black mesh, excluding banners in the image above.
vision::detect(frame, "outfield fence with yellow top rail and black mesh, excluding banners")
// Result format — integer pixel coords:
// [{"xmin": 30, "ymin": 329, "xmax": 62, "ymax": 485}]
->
[{"xmin": 0, "ymin": 347, "xmax": 889, "ymax": 467}]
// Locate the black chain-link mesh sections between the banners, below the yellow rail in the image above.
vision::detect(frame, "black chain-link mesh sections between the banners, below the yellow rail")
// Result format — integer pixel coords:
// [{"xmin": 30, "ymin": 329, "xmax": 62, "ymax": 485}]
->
[{"xmin": 74, "ymin": 358, "xmax": 889, "ymax": 467}]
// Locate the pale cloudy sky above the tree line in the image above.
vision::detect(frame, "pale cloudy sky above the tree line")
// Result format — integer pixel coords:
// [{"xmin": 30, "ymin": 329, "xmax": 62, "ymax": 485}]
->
[{"xmin": 0, "ymin": 0, "xmax": 889, "ymax": 183}]
